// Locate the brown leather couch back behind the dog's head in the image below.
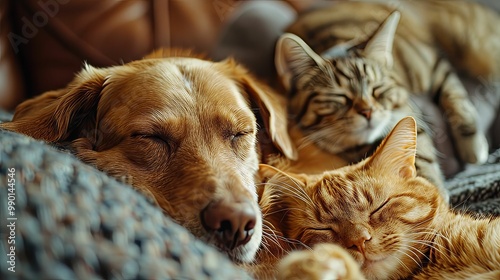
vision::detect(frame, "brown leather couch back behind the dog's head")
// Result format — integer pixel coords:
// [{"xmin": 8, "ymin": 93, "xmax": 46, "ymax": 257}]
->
[{"xmin": 0, "ymin": 0, "xmax": 314, "ymax": 110}]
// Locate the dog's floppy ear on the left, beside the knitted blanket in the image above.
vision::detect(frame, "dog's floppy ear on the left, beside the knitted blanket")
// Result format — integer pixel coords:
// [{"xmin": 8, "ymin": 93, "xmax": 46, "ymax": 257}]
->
[{"xmin": 0, "ymin": 65, "xmax": 107, "ymax": 142}]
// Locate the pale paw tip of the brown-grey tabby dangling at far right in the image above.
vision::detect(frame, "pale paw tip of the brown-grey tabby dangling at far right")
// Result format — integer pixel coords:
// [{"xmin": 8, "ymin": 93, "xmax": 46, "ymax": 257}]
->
[{"xmin": 457, "ymin": 133, "xmax": 489, "ymax": 164}]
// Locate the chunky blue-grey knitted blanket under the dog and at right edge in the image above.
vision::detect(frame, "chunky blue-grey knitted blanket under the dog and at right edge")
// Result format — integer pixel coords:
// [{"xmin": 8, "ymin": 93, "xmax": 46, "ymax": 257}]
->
[{"xmin": 0, "ymin": 112, "xmax": 500, "ymax": 279}]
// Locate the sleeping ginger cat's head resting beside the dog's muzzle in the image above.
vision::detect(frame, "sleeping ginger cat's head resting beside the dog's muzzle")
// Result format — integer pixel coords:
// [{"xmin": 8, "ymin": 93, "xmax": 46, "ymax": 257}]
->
[{"xmin": 260, "ymin": 117, "xmax": 446, "ymax": 279}]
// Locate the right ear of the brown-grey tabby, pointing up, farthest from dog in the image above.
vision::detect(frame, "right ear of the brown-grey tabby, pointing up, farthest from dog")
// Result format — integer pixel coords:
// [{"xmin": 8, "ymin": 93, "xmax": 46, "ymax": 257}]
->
[{"xmin": 363, "ymin": 11, "xmax": 401, "ymax": 68}]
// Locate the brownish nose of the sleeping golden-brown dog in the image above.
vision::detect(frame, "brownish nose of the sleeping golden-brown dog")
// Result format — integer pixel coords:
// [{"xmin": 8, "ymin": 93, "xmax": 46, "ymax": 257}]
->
[{"xmin": 201, "ymin": 200, "xmax": 257, "ymax": 249}]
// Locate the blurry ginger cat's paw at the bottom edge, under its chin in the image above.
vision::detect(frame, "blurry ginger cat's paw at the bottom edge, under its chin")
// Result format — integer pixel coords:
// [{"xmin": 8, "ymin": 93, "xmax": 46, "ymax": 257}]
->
[{"xmin": 276, "ymin": 244, "xmax": 365, "ymax": 280}]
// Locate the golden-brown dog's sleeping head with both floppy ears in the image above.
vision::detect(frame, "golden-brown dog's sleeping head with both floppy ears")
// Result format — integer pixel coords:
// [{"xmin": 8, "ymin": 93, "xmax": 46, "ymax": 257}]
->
[{"xmin": 0, "ymin": 52, "xmax": 294, "ymax": 262}]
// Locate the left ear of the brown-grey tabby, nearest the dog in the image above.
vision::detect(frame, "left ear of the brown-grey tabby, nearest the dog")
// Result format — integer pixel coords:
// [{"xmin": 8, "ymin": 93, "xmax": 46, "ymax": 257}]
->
[{"xmin": 274, "ymin": 33, "xmax": 324, "ymax": 92}]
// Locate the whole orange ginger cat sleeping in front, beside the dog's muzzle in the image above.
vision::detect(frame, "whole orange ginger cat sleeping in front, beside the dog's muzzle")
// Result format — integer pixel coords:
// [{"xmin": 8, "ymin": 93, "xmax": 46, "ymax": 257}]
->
[{"xmin": 254, "ymin": 117, "xmax": 500, "ymax": 280}]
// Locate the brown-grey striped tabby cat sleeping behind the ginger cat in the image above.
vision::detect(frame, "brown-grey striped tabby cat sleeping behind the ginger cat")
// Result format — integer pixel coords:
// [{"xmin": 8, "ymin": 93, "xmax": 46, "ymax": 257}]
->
[{"xmin": 273, "ymin": 0, "xmax": 500, "ymax": 195}]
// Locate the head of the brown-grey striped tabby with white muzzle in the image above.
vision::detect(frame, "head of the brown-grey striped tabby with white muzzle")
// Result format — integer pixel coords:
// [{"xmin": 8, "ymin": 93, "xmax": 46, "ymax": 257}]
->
[{"xmin": 275, "ymin": 12, "xmax": 408, "ymax": 154}]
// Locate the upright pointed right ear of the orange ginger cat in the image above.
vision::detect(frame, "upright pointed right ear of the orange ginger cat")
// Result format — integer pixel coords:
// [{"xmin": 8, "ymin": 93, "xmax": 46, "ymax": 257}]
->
[{"xmin": 366, "ymin": 117, "xmax": 417, "ymax": 179}]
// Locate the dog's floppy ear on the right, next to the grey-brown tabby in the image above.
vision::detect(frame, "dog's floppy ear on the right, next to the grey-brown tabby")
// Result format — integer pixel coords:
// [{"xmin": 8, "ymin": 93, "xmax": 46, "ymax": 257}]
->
[{"xmin": 223, "ymin": 59, "xmax": 297, "ymax": 160}]
